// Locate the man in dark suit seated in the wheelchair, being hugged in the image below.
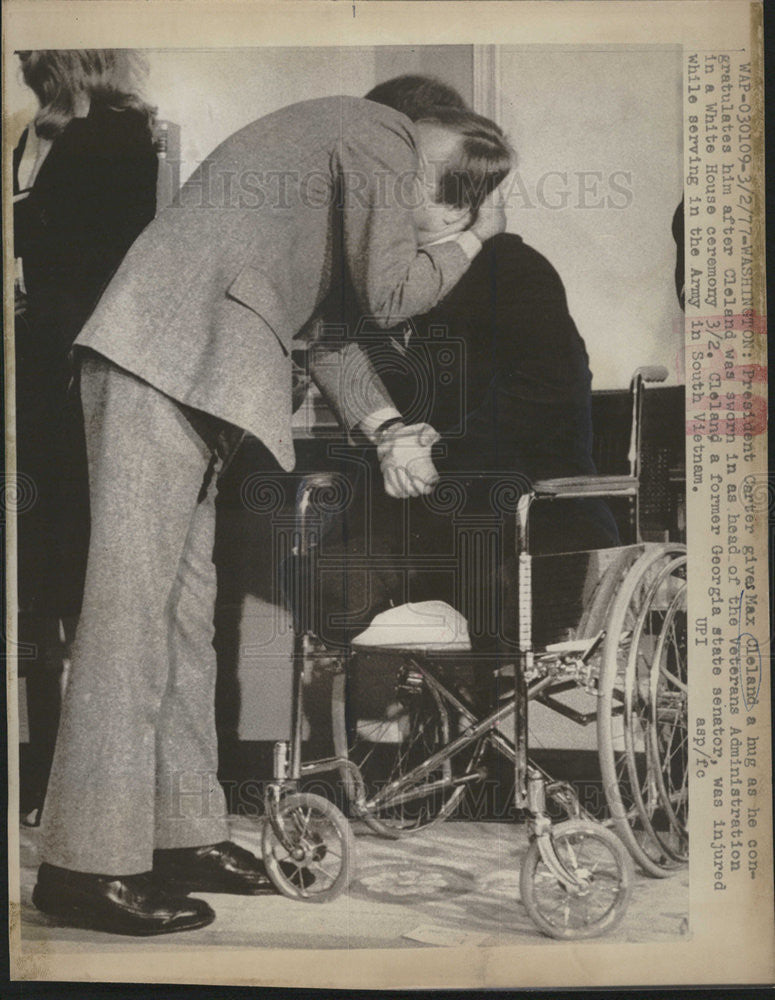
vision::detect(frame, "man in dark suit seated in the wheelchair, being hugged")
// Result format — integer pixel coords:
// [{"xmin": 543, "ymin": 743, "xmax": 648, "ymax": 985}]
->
[{"xmin": 310, "ymin": 77, "xmax": 619, "ymax": 648}]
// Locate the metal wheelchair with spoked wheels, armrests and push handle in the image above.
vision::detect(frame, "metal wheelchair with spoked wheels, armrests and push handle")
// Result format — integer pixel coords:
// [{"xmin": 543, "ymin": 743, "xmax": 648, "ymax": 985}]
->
[{"xmin": 264, "ymin": 368, "xmax": 688, "ymax": 937}]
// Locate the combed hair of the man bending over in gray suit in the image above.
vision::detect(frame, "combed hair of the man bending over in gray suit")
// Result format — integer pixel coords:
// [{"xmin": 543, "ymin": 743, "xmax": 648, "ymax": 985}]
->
[{"xmin": 418, "ymin": 107, "xmax": 515, "ymax": 212}]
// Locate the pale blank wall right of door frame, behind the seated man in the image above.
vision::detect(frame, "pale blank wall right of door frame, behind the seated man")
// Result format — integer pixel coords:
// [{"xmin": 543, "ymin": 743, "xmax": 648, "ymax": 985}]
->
[{"xmin": 495, "ymin": 46, "xmax": 683, "ymax": 389}]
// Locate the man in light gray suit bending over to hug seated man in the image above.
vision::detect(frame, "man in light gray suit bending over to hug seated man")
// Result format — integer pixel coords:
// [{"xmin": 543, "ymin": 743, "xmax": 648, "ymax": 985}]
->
[{"xmin": 33, "ymin": 97, "xmax": 509, "ymax": 934}]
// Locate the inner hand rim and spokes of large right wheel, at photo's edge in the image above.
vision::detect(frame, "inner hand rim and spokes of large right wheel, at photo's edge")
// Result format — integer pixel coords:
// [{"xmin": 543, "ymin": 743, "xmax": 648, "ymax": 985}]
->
[{"xmin": 648, "ymin": 582, "xmax": 689, "ymax": 861}]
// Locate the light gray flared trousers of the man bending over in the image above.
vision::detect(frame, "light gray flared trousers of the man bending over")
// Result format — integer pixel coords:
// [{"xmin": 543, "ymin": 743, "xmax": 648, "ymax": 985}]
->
[{"xmin": 41, "ymin": 354, "xmax": 238, "ymax": 875}]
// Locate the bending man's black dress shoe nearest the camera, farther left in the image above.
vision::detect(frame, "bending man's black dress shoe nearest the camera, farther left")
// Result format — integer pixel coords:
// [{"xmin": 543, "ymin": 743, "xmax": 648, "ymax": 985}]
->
[{"xmin": 32, "ymin": 863, "xmax": 215, "ymax": 936}]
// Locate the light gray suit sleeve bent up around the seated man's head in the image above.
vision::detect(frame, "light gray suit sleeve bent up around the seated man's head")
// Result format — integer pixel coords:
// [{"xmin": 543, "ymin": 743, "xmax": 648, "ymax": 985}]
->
[{"xmin": 339, "ymin": 118, "xmax": 470, "ymax": 328}]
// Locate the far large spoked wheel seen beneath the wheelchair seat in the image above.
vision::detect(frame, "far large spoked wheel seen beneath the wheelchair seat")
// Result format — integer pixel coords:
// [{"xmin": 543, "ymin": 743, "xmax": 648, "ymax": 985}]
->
[{"xmin": 332, "ymin": 661, "xmax": 475, "ymax": 839}]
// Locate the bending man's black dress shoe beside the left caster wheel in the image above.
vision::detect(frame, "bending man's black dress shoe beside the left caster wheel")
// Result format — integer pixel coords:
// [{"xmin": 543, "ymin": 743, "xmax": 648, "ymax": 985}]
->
[{"xmin": 153, "ymin": 840, "xmax": 277, "ymax": 896}]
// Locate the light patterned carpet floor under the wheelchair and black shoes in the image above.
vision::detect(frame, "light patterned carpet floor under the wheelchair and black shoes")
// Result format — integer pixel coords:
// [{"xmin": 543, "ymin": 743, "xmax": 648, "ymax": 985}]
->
[{"xmin": 21, "ymin": 819, "xmax": 689, "ymax": 952}]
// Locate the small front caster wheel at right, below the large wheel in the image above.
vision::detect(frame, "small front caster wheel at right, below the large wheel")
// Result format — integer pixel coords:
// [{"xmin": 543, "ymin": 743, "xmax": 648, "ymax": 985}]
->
[{"xmin": 519, "ymin": 820, "xmax": 633, "ymax": 939}]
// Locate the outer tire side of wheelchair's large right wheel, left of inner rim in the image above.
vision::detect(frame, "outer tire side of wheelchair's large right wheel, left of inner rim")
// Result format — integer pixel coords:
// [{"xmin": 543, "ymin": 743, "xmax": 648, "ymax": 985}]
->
[{"xmin": 597, "ymin": 545, "xmax": 686, "ymax": 878}]
